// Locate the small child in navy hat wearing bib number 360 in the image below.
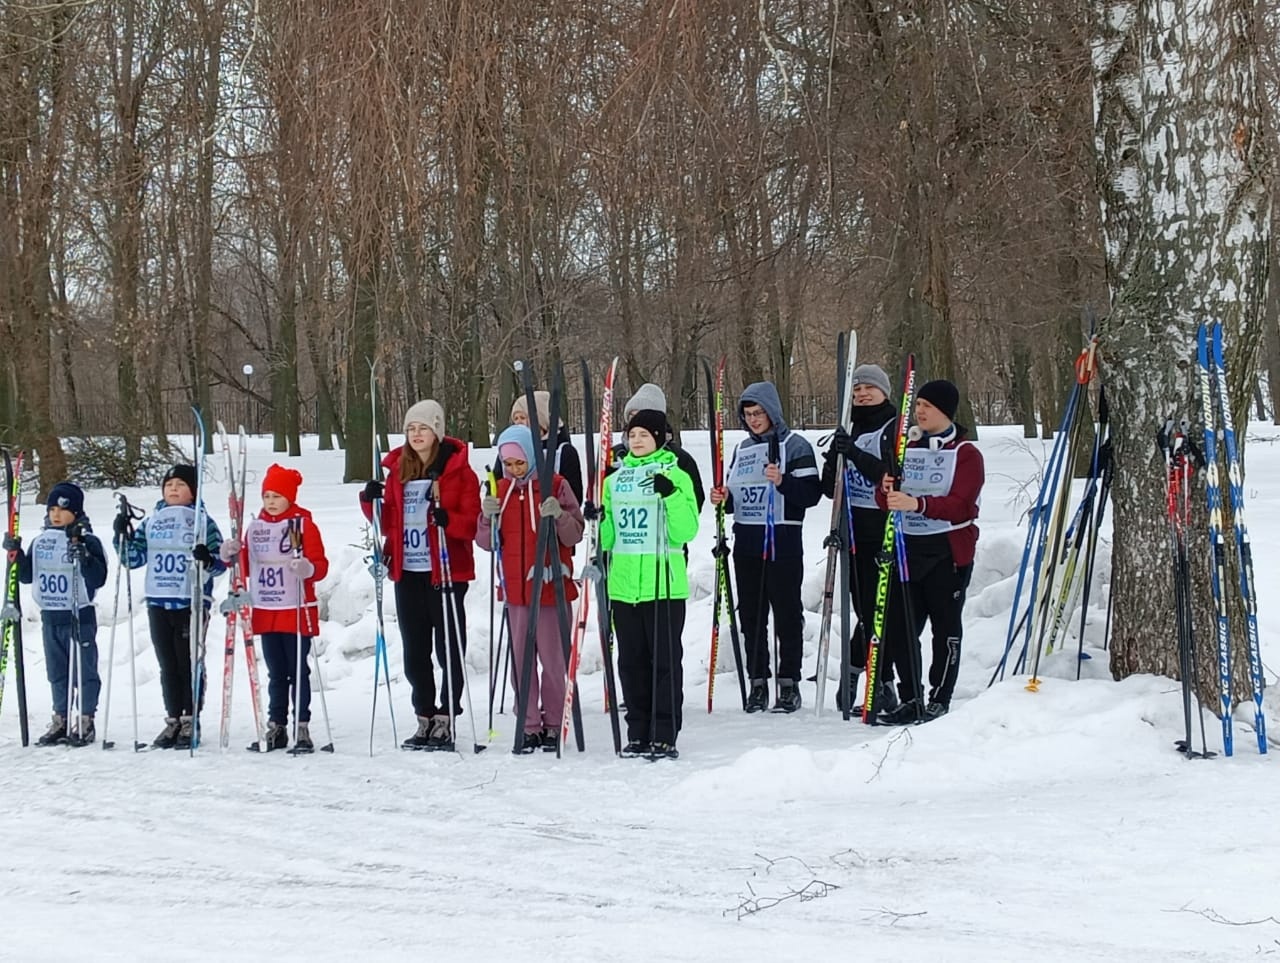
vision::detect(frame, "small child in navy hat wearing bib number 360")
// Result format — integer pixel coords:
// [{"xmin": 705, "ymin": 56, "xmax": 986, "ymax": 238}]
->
[{"xmin": 4, "ymin": 482, "xmax": 106, "ymax": 745}]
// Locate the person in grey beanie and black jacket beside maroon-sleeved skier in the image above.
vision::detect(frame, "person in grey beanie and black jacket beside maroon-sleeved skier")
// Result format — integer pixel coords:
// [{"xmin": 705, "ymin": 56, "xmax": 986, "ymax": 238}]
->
[{"xmin": 822, "ymin": 364, "xmax": 897, "ymax": 709}]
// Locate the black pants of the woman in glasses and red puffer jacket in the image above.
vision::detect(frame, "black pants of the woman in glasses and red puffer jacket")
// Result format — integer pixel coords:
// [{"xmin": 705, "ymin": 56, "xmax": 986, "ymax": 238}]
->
[{"xmin": 396, "ymin": 572, "xmax": 467, "ymax": 717}]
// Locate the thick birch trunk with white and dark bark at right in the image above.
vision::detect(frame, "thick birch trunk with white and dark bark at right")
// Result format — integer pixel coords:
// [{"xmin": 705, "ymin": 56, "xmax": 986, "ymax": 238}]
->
[{"xmin": 1093, "ymin": 0, "xmax": 1271, "ymax": 704}]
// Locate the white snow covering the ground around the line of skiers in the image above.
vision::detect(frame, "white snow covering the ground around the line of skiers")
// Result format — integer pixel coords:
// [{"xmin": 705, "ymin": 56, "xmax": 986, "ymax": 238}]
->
[{"xmin": 0, "ymin": 425, "xmax": 1280, "ymax": 962}]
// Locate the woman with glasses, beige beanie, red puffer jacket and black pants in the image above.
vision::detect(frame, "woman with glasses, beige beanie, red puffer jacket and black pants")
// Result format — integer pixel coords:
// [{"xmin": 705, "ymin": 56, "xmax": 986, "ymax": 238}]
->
[{"xmin": 360, "ymin": 401, "xmax": 480, "ymax": 750}]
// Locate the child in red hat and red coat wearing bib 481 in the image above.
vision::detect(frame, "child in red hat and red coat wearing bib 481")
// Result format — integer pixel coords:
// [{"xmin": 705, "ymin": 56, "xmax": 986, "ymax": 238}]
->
[{"xmin": 219, "ymin": 465, "xmax": 329, "ymax": 753}]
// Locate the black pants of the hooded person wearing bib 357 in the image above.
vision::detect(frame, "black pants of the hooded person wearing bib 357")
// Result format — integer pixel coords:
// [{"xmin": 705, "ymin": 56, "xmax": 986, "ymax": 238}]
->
[{"xmin": 733, "ymin": 554, "xmax": 804, "ymax": 683}]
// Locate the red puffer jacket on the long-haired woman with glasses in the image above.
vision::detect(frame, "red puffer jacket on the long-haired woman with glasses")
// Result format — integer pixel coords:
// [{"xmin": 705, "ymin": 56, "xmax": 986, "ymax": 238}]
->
[{"xmin": 360, "ymin": 438, "xmax": 480, "ymax": 585}]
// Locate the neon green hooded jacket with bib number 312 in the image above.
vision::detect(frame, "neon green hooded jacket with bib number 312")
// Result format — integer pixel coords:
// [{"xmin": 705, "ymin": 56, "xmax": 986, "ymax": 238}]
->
[{"xmin": 600, "ymin": 448, "xmax": 698, "ymax": 604}]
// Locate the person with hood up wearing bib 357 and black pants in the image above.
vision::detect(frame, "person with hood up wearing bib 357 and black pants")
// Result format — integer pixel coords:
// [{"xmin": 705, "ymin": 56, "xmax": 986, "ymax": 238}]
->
[{"xmin": 712, "ymin": 382, "xmax": 822, "ymax": 712}]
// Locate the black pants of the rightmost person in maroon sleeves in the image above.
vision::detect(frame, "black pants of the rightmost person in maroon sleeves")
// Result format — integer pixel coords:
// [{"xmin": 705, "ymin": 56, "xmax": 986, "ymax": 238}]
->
[{"xmin": 881, "ymin": 558, "xmax": 973, "ymax": 706}]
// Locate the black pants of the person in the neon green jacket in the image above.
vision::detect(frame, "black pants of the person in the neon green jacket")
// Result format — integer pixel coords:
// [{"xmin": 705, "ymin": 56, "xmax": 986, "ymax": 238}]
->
[{"xmin": 611, "ymin": 598, "xmax": 685, "ymax": 745}]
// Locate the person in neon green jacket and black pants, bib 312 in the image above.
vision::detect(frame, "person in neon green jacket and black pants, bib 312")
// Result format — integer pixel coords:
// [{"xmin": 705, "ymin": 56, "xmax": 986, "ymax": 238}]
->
[{"xmin": 600, "ymin": 411, "xmax": 698, "ymax": 759}]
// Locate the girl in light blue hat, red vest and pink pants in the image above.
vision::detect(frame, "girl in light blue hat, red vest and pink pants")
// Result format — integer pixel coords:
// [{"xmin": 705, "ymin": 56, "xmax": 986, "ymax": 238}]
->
[{"xmin": 476, "ymin": 425, "xmax": 586, "ymax": 753}]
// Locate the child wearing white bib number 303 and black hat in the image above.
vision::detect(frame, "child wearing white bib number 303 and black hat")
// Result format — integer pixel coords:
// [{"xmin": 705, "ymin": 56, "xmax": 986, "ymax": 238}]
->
[{"xmin": 111, "ymin": 465, "xmax": 227, "ymax": 749}]
